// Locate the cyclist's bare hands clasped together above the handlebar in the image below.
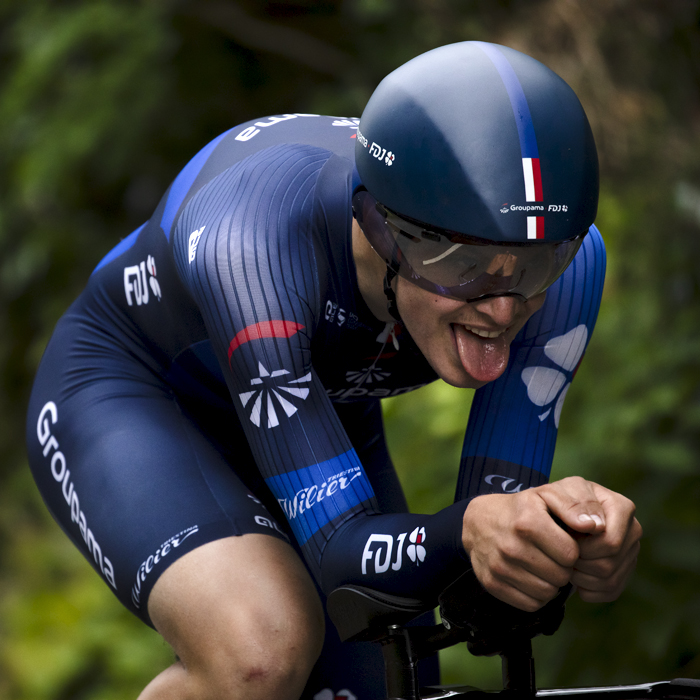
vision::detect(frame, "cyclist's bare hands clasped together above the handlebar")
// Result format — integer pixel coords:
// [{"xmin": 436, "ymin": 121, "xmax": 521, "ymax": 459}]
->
[{"xmin": 462, "ymin": 477, "xmax": 642, "ymax": 611}]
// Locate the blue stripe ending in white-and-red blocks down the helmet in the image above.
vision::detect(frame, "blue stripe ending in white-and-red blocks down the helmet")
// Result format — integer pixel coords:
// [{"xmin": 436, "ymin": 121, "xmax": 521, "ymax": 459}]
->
[{"xmin": 479, "ymin": 42, "xmax": 544, "ymax": 240}]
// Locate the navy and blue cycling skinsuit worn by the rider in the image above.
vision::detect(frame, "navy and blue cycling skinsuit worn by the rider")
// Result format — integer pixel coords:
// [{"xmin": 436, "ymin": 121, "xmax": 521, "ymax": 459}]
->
[{"xmin": 27, "ymin": 114, "xmax": 605, "ymax": 697}]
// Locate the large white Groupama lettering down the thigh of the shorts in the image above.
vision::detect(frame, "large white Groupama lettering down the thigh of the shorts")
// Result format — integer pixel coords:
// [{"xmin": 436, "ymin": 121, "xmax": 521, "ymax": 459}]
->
[{"xmin": 36, "ymin": 401, "xmax": 117, "ymax": 589}]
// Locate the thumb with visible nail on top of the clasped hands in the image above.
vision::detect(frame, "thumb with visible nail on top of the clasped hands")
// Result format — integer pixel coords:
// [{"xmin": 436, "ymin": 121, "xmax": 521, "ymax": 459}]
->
[{"xmin": 540, "ymin": 477, "xmax": 606, "ymax": 533}]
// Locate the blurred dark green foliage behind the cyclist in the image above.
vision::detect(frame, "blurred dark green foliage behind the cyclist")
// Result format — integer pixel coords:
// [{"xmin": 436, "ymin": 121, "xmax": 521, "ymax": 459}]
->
[{"xmin": 0, "ymin": 0, "xmax": 700, "ymax": 700}]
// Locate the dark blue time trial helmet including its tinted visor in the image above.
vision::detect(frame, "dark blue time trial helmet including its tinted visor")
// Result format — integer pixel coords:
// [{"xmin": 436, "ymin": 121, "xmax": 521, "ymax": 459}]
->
[{"xmin": 353, "ymin": 41, "xmax": 598, "ymax": 301}]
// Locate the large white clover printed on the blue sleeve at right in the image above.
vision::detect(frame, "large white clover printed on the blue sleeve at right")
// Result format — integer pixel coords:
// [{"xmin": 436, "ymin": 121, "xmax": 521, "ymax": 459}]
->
[{"xmin": 520, "ymin": 324, "xmax": 588, "ymax": 428}]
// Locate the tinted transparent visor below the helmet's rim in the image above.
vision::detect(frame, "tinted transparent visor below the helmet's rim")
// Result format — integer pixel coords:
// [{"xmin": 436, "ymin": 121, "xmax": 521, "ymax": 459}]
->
[{"xmin": 352, "ymin": 190, "xmax": 587, "ymax": 301}]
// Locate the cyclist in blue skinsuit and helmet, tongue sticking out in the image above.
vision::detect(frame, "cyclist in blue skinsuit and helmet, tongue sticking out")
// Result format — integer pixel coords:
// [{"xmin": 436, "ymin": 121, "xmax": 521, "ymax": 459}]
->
[{"xmin": 27, "ymin": 42, "xmax": 641, "ymax": 700}]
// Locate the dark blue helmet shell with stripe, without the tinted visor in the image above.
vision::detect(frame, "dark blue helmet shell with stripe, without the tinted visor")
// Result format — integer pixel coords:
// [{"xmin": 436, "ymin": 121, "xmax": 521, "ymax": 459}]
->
[{"xmin": 355, "ymin": 41, "xmax": 598, "ymax": 243}]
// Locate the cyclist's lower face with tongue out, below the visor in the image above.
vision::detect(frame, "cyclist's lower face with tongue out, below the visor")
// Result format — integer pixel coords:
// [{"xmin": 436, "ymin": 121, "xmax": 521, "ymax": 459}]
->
[{"xmin": 396, "ymin": 277, "xmax": 546, "ymax": 389}]
